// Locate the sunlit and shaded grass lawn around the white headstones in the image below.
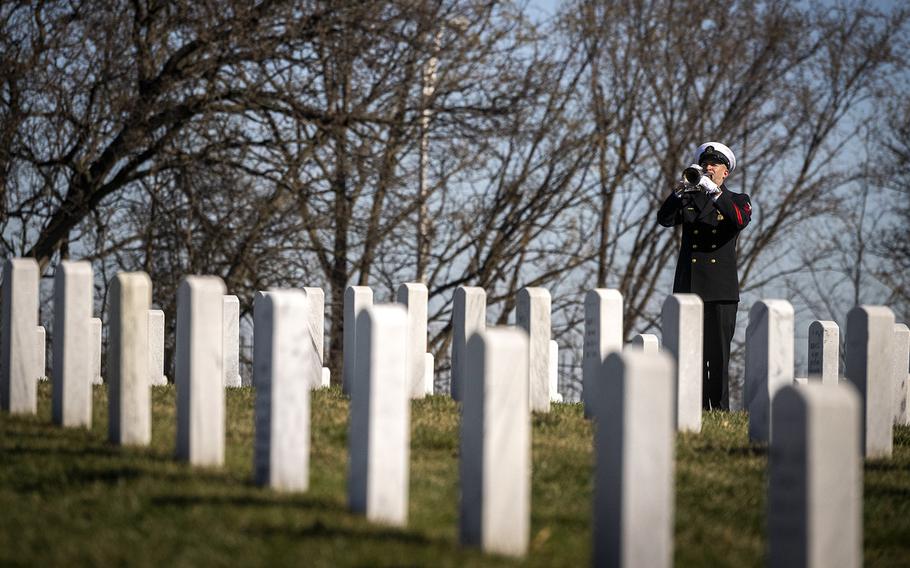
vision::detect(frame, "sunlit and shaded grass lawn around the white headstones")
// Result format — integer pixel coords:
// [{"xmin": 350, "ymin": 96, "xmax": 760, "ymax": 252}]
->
[{"xmin": 0, "ymin": 382, "xmax": 910, "ymax": 567}]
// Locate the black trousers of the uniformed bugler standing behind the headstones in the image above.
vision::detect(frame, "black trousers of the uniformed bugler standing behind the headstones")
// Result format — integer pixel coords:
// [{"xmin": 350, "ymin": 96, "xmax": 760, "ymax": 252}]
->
[{"xmin": 701, "ymin": 302, "xmax": 739, "ymax": 410}]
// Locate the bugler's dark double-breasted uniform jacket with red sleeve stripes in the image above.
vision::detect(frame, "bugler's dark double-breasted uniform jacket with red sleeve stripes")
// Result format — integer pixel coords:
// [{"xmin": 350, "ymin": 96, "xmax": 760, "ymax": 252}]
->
[{"xmin": 657, "ymin": 185, "xmax": 752, "ymax": 302}]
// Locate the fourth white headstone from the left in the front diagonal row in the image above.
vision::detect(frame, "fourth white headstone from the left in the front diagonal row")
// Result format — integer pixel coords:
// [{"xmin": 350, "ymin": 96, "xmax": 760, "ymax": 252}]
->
[{"xmin": 174, "ymin": 276, "xmax": 228, "ymax": 466}]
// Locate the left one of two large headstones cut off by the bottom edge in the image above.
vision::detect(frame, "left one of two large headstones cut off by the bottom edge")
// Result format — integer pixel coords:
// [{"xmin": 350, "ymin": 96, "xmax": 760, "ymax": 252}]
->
[{"xmin": 593, "ymin": 350, "xmax": 676, "ymax": 568}]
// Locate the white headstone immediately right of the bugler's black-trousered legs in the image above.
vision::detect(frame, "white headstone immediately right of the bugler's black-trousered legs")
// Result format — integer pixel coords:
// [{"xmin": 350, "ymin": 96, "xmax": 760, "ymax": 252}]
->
[{"xmin": 743, "ymin": 300, "xmax": 793, "ymax": 443}]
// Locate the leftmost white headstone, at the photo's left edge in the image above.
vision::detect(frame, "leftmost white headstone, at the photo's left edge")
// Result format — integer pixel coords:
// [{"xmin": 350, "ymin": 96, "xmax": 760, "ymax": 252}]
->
[{"xmin": 0, "ymin": 258, "xmax": 44, "ymax": 414}]
